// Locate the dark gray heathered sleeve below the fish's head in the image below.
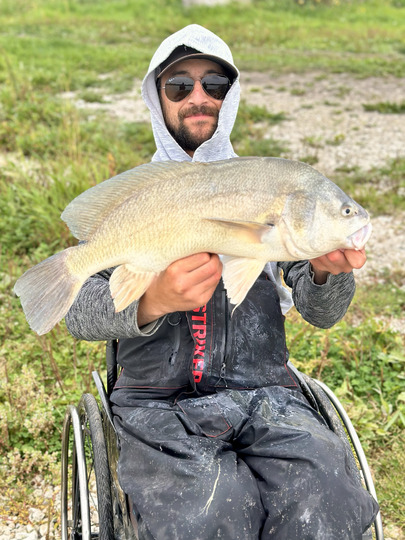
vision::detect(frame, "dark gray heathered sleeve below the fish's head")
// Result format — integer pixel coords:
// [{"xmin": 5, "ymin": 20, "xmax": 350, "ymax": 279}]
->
[{"xmin": 280, "ymin": 261, "xmax": 356, "ymax": 328}]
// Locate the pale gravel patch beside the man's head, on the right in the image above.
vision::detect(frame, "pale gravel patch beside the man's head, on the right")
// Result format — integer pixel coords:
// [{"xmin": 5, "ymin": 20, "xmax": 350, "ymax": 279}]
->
[{"xmin": 242, "ymin": 73, "xmax": 405, "ymax": 175}]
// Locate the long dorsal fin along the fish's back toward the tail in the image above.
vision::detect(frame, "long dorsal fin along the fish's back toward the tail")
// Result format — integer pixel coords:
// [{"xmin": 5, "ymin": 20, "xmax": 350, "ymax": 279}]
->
[{"xmin": 61, "ymin": 161, "xmax": 197, "ymax": 240}]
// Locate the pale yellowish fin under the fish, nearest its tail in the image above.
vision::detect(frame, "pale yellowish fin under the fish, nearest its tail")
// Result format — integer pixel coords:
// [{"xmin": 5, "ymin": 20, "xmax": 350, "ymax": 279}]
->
[{"xmin": 110, "ymin": 264, "xmax": 156, "ymax": 313}]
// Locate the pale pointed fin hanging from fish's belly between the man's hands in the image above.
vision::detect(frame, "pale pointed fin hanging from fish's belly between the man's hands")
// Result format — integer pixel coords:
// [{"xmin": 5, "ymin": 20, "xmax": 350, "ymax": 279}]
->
[{"xmin": 222, "ymin": 257, "xmax": 265, "ymax": 310}]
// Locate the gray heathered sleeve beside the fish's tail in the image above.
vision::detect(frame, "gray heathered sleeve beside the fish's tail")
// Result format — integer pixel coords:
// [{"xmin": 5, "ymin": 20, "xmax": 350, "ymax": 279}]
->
[{"xmin": 65, "ymin": 268, "xmax": 164, "ymax": 341}]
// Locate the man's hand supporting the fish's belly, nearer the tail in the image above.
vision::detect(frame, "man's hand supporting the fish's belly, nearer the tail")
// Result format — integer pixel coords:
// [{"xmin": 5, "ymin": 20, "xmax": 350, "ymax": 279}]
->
[{"xmin": 138, "ymin": 253, "xmax": 222, "ymax": 327}]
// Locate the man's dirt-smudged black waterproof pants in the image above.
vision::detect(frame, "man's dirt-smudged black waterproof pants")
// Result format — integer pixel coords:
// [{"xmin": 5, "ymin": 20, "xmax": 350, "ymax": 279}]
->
[{"xmin": 112, "ymin": 386, "xmax": 378, "ymax": 540}]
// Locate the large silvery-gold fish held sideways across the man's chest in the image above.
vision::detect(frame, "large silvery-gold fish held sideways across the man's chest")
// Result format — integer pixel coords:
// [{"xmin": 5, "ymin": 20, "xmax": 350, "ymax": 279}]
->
[{"xmin": 14, "ymin": 157, "xmax": 371, "ymax": 334}]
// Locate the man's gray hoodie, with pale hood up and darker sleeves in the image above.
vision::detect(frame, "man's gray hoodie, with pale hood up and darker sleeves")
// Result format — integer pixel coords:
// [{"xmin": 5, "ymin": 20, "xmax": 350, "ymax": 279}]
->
[{"xmin": 66, "ymin": 24, "xmax": 354, "ymax": 340}]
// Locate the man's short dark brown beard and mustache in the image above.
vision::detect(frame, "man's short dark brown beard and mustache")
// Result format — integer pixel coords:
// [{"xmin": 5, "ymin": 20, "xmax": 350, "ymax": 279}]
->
[{"xmin": 166, "ymin": 105, "xmax": 218, "ymax": 152}]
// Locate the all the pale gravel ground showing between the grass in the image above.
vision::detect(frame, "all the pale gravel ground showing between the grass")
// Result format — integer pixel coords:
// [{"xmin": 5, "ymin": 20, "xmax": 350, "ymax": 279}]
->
[{"xmin": 0, "ymin": 73, "xmax": 405, "ymax": 540}]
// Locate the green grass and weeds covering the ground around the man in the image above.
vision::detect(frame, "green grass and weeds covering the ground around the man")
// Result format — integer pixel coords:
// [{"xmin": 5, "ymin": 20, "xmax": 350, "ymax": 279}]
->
[{"xmin": 0, "ymin": 0, "xmax": 405, "ymax": 538}]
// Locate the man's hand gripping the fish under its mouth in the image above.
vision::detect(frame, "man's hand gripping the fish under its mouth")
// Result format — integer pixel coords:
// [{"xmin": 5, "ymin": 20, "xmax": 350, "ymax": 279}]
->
[{"xmin": 309, "ymin": 249, "xmax": 367, "ymax": 285}]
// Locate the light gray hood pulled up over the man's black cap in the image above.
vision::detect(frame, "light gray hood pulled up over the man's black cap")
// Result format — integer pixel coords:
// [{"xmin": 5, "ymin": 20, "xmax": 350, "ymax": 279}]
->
[{"xmin": 142, "ymin": 24, "xmax": 240, "ymax": 161}]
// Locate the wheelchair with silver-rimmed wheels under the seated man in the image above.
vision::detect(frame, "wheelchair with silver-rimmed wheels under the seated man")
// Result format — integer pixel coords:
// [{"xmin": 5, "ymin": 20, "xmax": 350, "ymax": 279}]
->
[{"xmin": 61, "ymin": 340, "xmax": 384, "ymax": 540}]
